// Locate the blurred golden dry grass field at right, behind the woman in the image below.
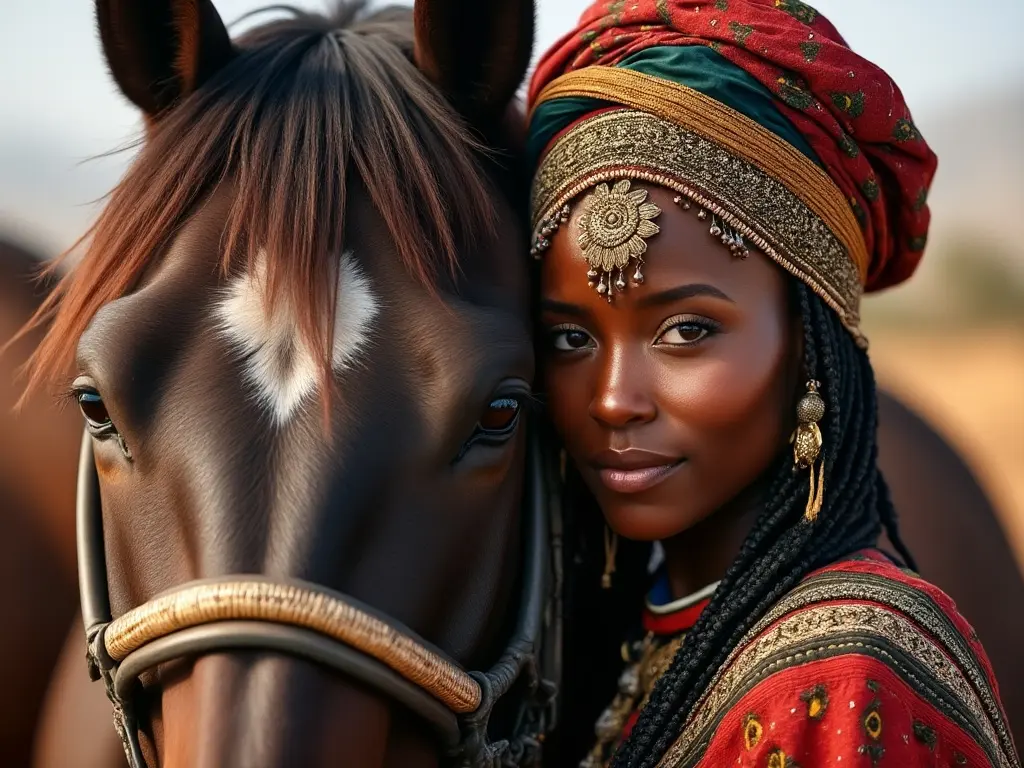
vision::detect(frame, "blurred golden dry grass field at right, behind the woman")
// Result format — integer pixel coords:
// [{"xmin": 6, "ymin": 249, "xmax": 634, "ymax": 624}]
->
[{"xmin": 868, "ymin": 328, "xmax": 1024, "ymax": 569}]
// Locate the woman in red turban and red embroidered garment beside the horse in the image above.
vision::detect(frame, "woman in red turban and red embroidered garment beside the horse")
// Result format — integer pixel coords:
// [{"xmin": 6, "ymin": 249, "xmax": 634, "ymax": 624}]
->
[{"xmin": 530, "ymin": 0, "xmax": 1019, "ymax": 768}]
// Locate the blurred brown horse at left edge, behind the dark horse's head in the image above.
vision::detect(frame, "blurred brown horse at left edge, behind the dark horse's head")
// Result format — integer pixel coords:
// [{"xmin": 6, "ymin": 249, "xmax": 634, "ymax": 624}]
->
[{"xmin": 0, "ymin": 238, "xmax": 82, "ymax": 766}]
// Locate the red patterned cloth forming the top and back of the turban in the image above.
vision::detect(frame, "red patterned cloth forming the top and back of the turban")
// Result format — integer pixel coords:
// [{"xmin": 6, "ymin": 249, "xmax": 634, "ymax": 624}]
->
[{"xmin": 529, "ymin": 0, "xmax": 937, "ymax": 291}]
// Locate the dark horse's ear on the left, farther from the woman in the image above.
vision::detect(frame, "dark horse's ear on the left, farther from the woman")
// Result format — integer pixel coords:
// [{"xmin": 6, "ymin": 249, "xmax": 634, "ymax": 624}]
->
[{"xmin": 96, "ymin": 0, "xmax": 233, "ymax": 119}]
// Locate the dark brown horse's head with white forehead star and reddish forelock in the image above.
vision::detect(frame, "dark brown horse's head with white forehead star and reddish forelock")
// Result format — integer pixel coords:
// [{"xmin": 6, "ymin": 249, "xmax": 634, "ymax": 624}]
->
[{"xmin": 25, "ymin": 0, "xmax": 552, "ymax": 766}]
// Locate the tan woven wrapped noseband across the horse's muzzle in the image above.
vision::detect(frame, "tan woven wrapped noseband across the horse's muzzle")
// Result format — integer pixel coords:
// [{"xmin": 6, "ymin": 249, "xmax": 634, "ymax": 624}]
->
[{"xmin": 104, "ymin": 580, "xmax": 482, "ymax": 713}]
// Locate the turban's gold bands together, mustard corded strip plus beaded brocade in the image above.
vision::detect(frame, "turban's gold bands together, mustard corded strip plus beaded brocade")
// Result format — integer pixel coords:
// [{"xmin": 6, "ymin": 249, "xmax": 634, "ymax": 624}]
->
[{"xmin": 530, "ymin": 67, "xmax": 868, "ymax": 346}]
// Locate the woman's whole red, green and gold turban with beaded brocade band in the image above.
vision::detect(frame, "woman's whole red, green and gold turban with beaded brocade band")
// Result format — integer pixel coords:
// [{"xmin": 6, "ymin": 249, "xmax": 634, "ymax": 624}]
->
[{"xmin": 527, "ymin": 0, "xmax": 937, "ymax": 344}]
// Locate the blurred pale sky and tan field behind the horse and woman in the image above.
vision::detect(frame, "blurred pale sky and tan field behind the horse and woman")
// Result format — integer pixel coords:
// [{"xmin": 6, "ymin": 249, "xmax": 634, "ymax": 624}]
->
[{"xmin": 6, "ymin": 0, "xmax": 1024, "ymax": 563}]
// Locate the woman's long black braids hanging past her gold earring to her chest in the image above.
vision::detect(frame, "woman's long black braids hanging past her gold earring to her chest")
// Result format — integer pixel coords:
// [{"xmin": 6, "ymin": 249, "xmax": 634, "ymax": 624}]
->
[{"xmin": 612, "ymin": 284, "xmax": 912, "ymax": 768}]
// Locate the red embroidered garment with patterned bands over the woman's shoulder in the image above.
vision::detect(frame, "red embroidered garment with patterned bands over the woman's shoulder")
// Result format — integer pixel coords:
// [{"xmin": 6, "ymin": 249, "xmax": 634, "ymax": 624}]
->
[{"xmin": 663, "ymin": 552, "xmax": 1019, "ymax": 768}]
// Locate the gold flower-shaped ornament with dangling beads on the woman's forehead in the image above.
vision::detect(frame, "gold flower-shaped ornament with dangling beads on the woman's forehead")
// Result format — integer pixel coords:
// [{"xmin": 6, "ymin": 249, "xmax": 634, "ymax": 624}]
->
[{"xmin": 578, "ymin": 179, "xmax": 662, "ymax": 301}]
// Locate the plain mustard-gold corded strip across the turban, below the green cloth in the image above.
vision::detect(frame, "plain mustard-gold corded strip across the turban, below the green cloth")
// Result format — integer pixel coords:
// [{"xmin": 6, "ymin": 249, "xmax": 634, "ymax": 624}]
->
[{"xmin": 530, "ymin": 67, "xmax": 870, "ymax": 285}]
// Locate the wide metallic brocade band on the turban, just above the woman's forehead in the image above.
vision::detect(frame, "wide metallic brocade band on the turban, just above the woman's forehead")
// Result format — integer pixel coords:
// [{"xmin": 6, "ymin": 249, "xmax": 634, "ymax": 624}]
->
[{"xmin": 530, "ymin": 110, "xmax": 867, "ymax": 347}]
